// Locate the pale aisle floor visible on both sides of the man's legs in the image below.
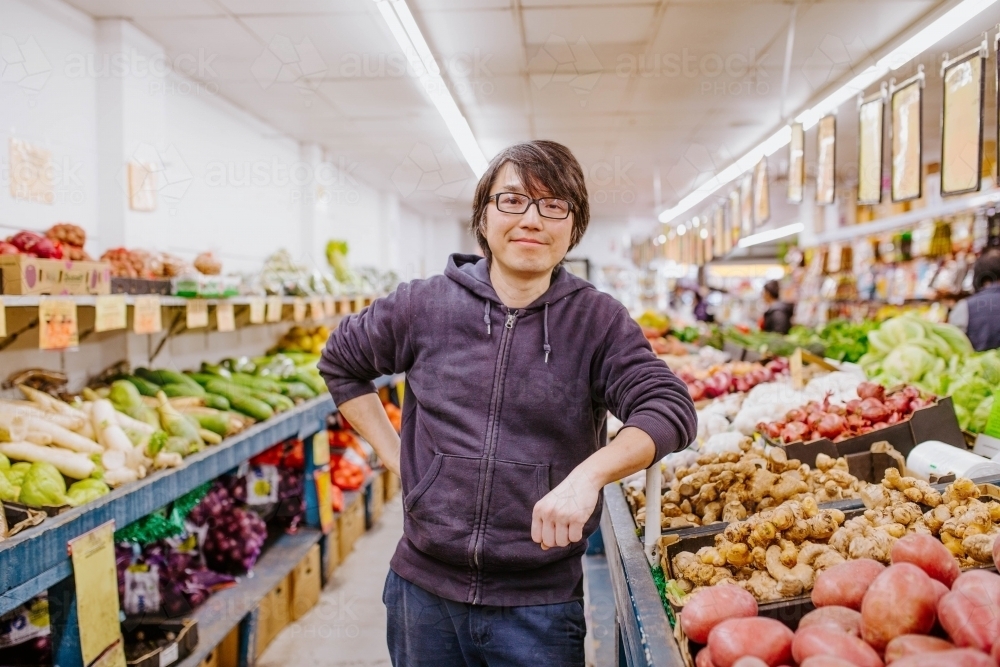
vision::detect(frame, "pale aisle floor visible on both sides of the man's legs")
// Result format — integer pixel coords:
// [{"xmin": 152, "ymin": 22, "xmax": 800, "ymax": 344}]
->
[{"xmin": 257, "ymin": 496, "xmax": 614, "ymax": 667}]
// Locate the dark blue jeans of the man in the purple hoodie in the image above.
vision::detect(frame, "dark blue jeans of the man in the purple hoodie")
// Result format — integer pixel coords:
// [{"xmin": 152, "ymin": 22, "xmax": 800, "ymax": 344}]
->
[{"xmin": 382, "ymin": 570, "xmax": 587, "ymax": 667}]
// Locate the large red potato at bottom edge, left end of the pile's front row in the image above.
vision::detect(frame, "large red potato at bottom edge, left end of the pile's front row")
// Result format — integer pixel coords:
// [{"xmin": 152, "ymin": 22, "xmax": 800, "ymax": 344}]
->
[{"xmin": 708, "ymin": 616, "xmax": 794, "ymax": 667}]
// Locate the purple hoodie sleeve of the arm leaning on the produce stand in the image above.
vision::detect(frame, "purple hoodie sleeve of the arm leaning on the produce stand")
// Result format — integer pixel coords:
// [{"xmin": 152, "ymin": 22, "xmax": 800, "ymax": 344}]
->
[{"xmin": 594, "ymin": 308, "xmax": 698, "ymax": 461}]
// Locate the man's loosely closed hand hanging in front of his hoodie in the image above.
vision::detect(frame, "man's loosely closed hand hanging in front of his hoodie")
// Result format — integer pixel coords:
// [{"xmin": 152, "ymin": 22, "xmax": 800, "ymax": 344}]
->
[{"xmin": 531, "ymin": 469, "xmax": 603, "ymax": 549}]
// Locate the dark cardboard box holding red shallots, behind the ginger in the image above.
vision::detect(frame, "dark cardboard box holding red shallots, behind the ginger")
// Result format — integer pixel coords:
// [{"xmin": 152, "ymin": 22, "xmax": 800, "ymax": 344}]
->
[{"xmin": 772, "ymin": 397, "xmax": 966, "ymax": 465}]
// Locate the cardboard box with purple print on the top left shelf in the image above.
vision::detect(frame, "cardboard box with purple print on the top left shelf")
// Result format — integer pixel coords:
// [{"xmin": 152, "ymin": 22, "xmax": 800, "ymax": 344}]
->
[{"xmin": 0, "ymin": 255, "xmax": 111, "ymax": 295}]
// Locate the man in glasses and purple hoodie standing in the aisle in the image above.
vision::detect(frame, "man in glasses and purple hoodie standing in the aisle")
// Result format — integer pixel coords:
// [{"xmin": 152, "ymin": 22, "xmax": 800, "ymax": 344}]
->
[{"xmin": 320, "ymin": 141, "xmax": 696, "ymax": 667}]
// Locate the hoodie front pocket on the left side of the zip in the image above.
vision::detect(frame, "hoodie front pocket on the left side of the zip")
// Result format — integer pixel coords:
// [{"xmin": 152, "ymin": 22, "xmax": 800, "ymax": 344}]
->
[{"xmin": 404, "ymin": 454, "xmax": 483, "ymax": 566}]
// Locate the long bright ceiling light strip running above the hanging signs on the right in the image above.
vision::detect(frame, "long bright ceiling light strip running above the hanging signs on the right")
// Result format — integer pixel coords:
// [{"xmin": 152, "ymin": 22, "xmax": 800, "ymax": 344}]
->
[{"xmin": 659, "ymin": 0, "xmax": 998, "ymax": 226}]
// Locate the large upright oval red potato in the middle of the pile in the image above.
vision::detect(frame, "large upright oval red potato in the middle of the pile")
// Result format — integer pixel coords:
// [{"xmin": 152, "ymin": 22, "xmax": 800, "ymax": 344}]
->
[{"xmin": 861, "ymin": 563, "xmax": 937, "ymax": 651}]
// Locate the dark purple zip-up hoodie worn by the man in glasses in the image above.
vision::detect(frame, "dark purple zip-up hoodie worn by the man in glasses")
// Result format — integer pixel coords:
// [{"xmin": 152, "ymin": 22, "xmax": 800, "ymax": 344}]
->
[{"xmin": 319, "ymin": 255, "xmax": 697, "ymax": 606}]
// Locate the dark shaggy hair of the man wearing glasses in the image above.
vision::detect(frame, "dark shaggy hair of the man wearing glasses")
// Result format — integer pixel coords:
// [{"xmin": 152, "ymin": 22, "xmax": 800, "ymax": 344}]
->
[{"xmin": 469, "ymin": 140, "xmax": 590, "ymax": 261}]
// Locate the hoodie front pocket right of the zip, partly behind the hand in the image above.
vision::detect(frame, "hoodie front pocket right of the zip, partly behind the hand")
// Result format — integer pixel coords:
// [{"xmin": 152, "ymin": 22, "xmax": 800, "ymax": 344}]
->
[{"xmin": 483, "ymin": 460, "xmax": 567, "ymax": 572}]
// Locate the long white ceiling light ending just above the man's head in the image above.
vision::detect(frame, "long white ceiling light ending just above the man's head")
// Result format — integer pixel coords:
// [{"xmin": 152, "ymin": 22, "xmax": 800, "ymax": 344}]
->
[{"xmin": 376, "ymin": 0, "xmax": 488, "ymax": 178}]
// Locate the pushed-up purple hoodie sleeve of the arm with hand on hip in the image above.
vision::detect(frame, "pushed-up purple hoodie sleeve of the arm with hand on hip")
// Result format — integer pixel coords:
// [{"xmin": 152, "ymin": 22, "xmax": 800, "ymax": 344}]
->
[{"xmin": 319, "ymin": 283, "xmax": 413, "ymax": 405}]
